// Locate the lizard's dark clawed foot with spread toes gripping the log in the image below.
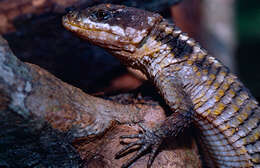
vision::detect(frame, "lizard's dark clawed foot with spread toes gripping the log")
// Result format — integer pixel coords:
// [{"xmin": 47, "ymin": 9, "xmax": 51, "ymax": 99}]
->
[{"xmin": 115, "ymin": 123, "xmax": 162, "ymax": 168}]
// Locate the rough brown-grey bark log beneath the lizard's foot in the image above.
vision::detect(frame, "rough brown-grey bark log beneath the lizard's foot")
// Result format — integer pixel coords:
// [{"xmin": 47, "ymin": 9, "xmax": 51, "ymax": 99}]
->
[{"xmin": 0, "ymin": 35, "xmax": 201, "ymax": 168}]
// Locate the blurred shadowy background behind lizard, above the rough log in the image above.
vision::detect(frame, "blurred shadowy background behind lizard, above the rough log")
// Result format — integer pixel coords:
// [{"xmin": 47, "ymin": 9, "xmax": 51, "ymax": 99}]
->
[{"xmin": 0, "ymin": 0, "xmax": 260, "ymax": 99}]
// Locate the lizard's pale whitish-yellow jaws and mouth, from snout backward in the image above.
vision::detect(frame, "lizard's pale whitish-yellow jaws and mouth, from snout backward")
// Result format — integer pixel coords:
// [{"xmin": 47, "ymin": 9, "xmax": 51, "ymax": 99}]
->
[{"xmin": 62, "ymin": 12, "xmax": 136, "ymax": 52}]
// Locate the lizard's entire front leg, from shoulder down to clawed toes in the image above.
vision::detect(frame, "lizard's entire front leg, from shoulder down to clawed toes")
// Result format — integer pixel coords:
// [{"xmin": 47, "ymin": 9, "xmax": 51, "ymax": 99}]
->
[{"xmin": 116, "ymin": 75, "xmax": 194, "ymax": 168}]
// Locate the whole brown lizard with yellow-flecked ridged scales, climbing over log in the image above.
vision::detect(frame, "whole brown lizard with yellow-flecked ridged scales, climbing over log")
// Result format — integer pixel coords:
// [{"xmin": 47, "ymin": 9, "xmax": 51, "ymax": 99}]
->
[{"xmin": 63, "ymin": 4, "xmax": 260, "ymax": 168}]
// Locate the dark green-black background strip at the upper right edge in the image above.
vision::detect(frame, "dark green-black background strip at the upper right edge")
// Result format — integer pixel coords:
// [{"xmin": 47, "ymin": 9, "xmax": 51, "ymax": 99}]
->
[{"xmin": 235, "ymin": 0, "xmax": 260, "ymax": 101}]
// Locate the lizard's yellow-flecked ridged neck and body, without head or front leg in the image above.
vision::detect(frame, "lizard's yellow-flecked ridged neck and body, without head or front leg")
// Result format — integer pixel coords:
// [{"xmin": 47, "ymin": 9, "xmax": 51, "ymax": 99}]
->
[{"xmin": 143, "ymin": 19, "xmax": 260, "ymax": 168}]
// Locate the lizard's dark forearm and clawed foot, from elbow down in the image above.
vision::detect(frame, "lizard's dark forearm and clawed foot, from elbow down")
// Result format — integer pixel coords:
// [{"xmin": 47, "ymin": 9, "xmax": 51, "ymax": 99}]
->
[{"xmin": 116, "ymin": 107, "xmax": 192, "ymax": 168}]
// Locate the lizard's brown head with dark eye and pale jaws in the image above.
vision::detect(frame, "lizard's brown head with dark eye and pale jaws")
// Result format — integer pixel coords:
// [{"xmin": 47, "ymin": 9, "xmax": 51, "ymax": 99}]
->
[{"xmin": 62, "ymin": 4, "xmax": 162, "ymax": 65}]
